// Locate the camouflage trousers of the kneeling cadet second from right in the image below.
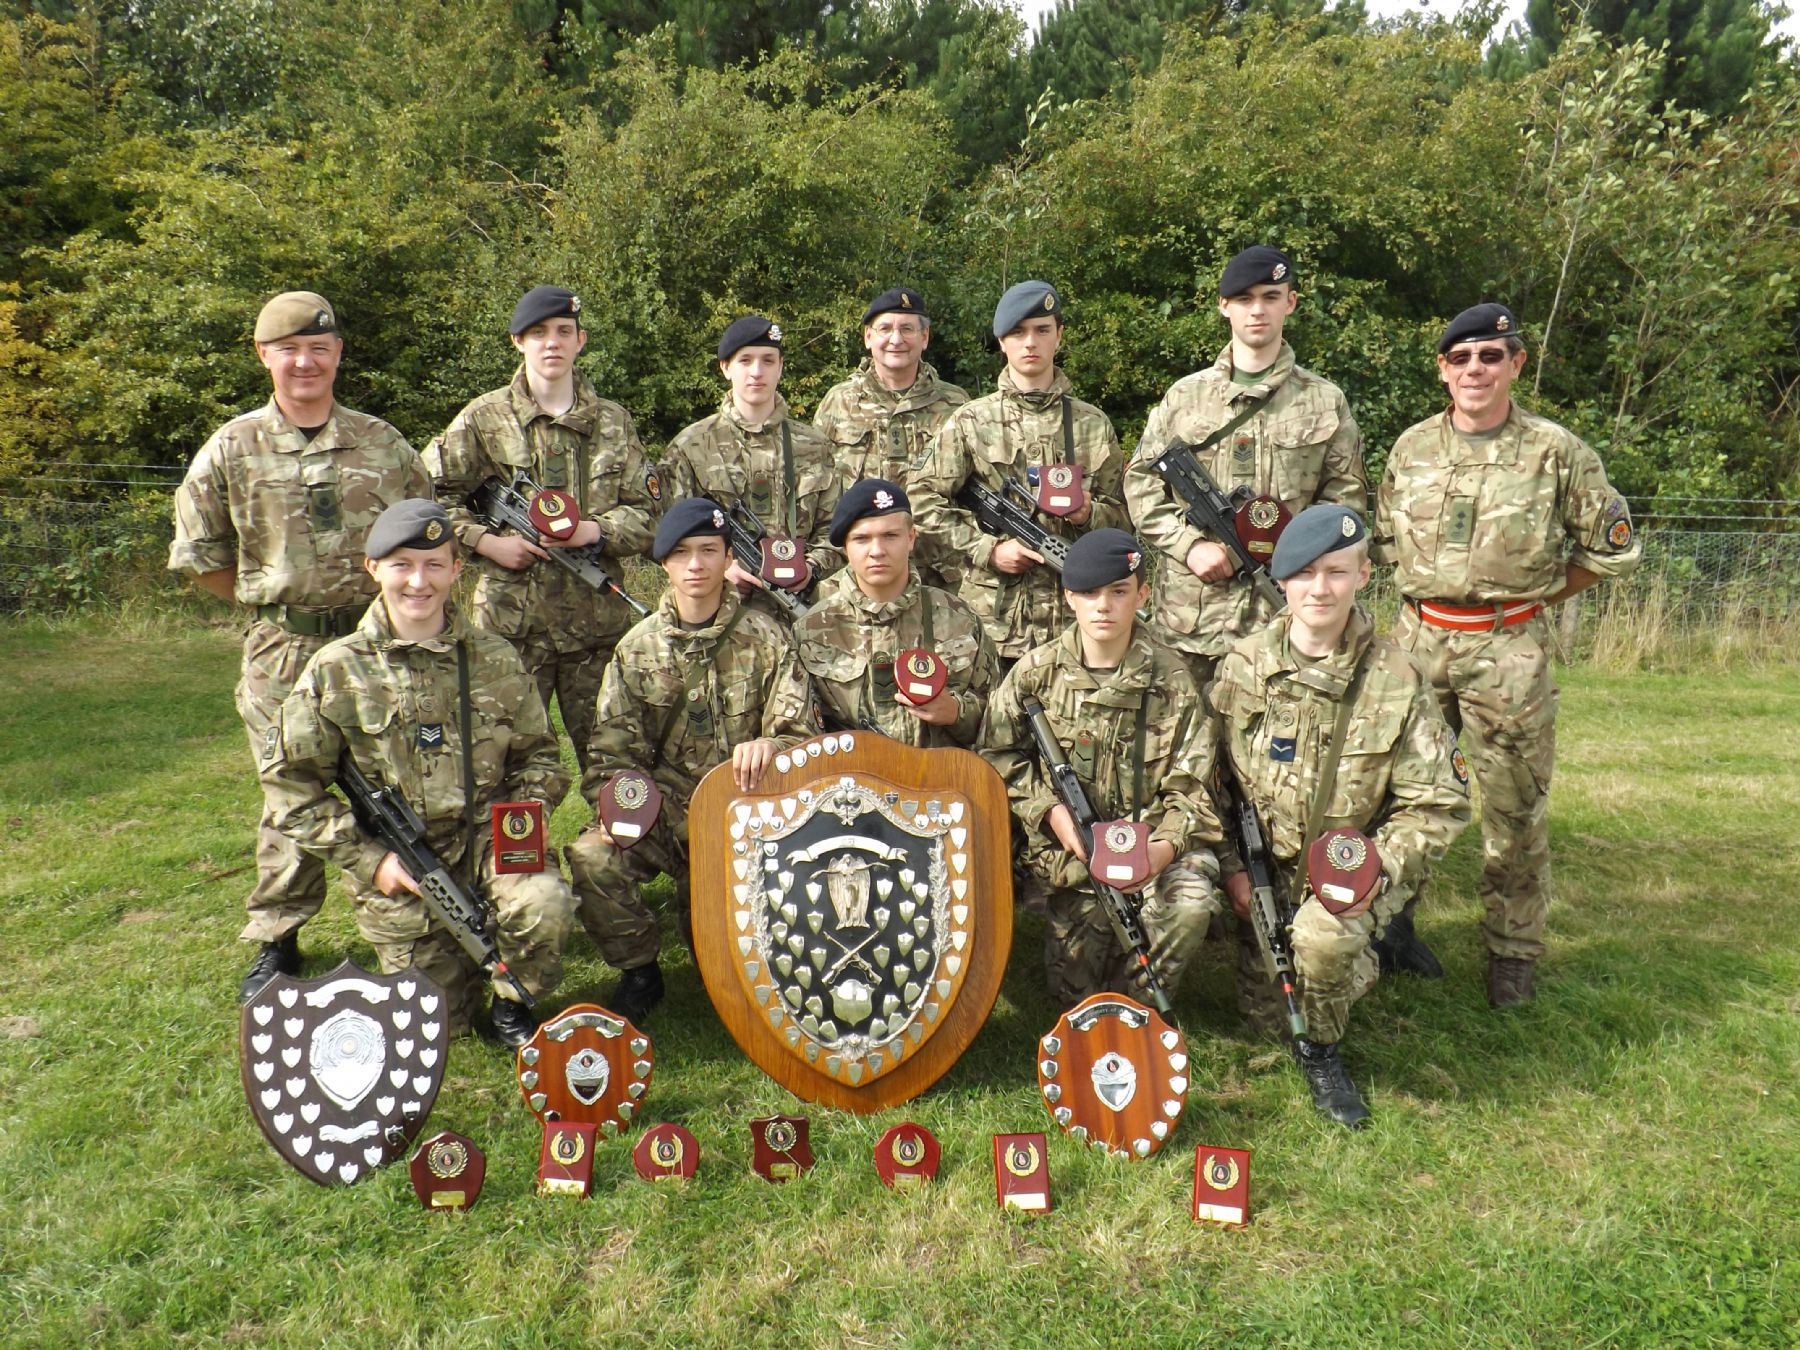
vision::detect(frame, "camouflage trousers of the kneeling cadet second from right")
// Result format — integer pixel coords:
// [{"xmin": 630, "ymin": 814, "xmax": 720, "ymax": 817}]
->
[{"xmin": 1044, "ymin": 853, "xmax": 1224, "ymax": 1008}]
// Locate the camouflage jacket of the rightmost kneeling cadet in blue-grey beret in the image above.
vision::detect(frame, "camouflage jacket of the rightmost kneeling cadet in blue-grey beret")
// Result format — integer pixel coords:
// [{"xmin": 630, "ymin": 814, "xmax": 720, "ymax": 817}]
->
[{"xmin": 1208, "ymin": 607, "xmax": 1469, "ymax": 903}]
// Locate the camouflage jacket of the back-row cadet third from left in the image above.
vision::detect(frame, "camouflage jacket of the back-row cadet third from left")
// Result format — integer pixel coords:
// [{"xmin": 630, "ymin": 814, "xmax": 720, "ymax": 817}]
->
[{"xmin": 662, "ymin": 394, "xmax": 844, "ymax": 578}]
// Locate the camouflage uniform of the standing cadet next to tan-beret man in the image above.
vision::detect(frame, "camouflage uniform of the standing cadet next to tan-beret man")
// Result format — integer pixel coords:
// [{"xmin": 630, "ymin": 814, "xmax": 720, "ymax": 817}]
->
[{"xmin": 425, "ymin": 367, "xmax": 655, "ymax": 760}]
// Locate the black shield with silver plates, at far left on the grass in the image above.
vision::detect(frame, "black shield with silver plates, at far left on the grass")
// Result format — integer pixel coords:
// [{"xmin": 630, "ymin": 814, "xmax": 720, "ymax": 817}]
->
[{"xmin": 238, "ymin": 961, "xmax": 450, "ymax": 1186}]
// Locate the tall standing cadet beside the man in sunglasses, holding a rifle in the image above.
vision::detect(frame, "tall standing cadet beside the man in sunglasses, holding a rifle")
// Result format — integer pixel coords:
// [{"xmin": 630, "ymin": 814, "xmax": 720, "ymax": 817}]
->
[{"xmin": 1125, "ymin": 245, "xmax": 1368, "ymax": 684}]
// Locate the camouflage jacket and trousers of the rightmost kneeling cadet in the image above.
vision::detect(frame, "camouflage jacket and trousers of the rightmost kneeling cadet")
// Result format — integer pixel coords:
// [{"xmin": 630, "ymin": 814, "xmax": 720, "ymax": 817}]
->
[{"xmin": 1208, "ymin": 607, "xmax": 1469, "ymax": 1044}]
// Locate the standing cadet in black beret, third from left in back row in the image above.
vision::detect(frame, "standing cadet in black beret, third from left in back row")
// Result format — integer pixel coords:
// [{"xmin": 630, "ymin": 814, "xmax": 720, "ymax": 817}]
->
[{"xmin": 662, "ymin": 315, "xmax": 844, "ymax": 590}]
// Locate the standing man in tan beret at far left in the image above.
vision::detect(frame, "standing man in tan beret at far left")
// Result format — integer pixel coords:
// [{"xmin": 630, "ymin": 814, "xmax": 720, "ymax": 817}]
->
[{"xmin": 169, "ymin": 290, "xmax": 432, "ymax": 999}]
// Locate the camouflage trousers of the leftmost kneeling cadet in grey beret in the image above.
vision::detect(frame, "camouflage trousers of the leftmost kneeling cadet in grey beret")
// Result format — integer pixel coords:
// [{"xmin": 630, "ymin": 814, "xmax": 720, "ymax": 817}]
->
[{"xmin": 346, "ymin": 846, "xmax": 574, "ymax": 1035}]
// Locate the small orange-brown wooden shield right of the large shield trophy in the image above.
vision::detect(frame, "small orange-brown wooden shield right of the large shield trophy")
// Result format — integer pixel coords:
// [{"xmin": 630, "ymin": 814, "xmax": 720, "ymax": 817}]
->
[{"xmin": 1037, "ymin": 994, "xmax": 1188, "ymax": 1159}]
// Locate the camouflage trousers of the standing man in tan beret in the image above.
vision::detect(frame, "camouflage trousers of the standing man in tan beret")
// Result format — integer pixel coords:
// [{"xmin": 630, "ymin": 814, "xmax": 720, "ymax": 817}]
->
[{"xmin": 236, "ymin": 619, "xmax": 331, "ymax": 941}]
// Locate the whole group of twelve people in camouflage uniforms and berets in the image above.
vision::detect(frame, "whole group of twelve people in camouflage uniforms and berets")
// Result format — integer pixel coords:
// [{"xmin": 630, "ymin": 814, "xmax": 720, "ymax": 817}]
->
[{"xmin": 169, "ymin": 247, "xmax": 1640, "ymax": 1127}]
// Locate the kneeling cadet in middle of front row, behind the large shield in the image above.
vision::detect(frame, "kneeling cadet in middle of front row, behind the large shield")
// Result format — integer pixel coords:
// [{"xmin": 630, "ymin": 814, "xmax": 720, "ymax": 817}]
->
[{"xmin": 794, "ymin": 479, "xmax": 1001, "ymax": 747}]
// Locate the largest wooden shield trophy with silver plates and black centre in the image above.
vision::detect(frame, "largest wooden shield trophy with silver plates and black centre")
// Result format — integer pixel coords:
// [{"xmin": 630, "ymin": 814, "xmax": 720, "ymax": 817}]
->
[{"xmin": 688, "ymin": 733, "xmax": 1012, "ymax": 1112}]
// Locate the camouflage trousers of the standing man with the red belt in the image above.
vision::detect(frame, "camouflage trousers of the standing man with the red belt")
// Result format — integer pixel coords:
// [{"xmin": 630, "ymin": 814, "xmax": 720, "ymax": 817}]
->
[{"xmin": 1393, "ymin": 605, "xmax": 1559, "ymax": 961}]
